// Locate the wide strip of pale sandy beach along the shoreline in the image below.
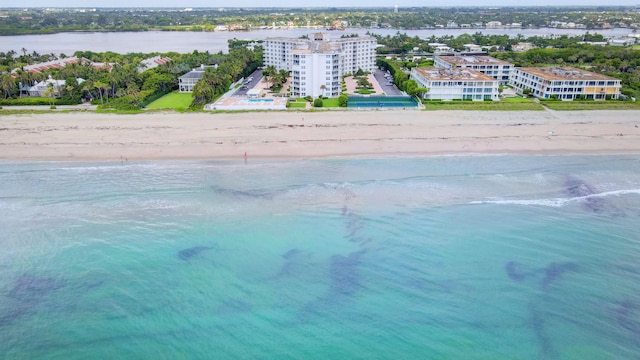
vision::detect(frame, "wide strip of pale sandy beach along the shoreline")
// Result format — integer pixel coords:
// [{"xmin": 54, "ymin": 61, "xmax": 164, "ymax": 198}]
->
[{"xmin": 0, "ymin": 110, "xmax": 640, "ymax": 161}]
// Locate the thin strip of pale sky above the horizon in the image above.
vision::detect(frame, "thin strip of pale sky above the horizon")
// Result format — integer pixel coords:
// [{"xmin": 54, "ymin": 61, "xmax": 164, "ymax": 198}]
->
[{"xmin": 0, "ymin": 0, "xmax": 640, "ymax": 8}]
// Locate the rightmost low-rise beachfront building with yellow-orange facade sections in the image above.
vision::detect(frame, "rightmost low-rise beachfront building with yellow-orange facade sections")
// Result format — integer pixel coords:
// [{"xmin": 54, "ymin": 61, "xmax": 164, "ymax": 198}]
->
[{"xmin": 509, "ymin": 67, "xmax": 621, "ymax": 100}]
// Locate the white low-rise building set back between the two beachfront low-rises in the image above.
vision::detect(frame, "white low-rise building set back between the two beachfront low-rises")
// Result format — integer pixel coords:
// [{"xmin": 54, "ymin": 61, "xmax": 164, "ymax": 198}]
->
[{"xmin": 433, "ymin": 55, "xmax": 514, "ymax": 84}]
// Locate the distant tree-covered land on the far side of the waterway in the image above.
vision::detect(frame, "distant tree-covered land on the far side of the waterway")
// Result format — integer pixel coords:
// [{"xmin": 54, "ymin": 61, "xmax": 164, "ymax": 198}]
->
[{"xmin": 0, "ymin": 5, "xmax": 640, "ymax": 35}]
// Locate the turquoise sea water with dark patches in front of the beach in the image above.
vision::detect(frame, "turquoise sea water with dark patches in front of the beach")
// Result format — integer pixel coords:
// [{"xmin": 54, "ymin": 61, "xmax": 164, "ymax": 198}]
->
[{"xmin": 0, "ymin": 156, "xmax": 640, "ymax": 359}]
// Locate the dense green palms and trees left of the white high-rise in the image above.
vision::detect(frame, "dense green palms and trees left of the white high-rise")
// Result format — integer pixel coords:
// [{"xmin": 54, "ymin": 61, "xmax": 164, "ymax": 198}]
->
[{"xmin": 0, "ymin": 40, "xmax": 262, "ymax": 111}]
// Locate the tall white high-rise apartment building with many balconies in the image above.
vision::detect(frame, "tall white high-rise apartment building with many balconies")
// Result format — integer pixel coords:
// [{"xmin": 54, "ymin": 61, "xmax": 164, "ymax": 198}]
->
[{"xmin": 264, "ymin": 33, "xmax": 377, "ymax": 97}]
